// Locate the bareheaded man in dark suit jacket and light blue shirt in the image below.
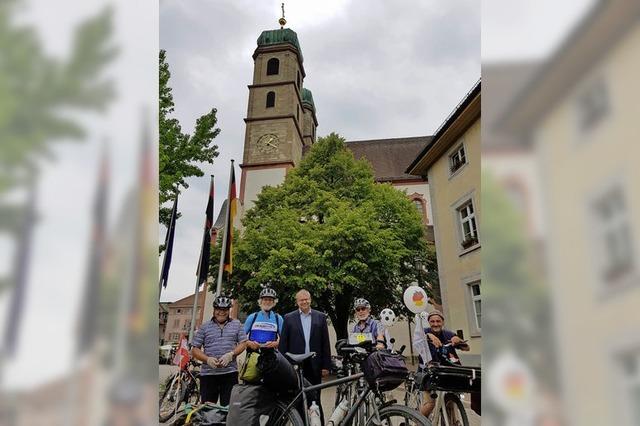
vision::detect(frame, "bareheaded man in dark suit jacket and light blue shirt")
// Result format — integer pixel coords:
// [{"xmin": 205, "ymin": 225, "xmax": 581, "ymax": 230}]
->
[{"xmin": 279, "ymin": 290, "xmax": 331, "ymax": 424}]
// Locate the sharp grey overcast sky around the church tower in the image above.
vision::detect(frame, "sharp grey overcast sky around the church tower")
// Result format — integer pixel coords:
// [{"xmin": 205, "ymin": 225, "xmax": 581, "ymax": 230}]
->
[{"xmin": 160, "ymin": 0, "xmax": 480, "ymax": 301}]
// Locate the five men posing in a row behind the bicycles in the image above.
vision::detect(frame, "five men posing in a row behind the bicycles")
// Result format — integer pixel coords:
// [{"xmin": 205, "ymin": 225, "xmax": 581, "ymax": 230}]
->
[{"xmin": 191, "ymin": 287, "xmax": 469, "ymax": 420}]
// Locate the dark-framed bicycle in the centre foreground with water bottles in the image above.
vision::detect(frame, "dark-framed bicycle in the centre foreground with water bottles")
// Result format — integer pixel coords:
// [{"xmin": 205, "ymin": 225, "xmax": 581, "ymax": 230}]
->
[{"xmin": 270, "ymin": 345, "xmax": 431, "ymax": 426}]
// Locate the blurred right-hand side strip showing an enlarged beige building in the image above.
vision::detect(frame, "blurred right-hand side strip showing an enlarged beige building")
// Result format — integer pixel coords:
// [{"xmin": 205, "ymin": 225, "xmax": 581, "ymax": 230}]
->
[{"xmin": 481, "ymin": 0, "xmax": 640, "ymax": 426}]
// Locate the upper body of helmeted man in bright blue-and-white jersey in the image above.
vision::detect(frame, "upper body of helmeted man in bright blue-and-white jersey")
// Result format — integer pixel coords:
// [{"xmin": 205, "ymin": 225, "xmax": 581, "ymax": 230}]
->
[{"xmin": 244, "ymin": 286, "xmax": 283, "ymax": 351}]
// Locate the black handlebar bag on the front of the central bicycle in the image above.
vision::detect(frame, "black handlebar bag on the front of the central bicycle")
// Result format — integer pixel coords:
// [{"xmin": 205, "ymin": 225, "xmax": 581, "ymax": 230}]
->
[{"xmin": 362, "ymin": 351, "xmax": 409, "ymax": 391}]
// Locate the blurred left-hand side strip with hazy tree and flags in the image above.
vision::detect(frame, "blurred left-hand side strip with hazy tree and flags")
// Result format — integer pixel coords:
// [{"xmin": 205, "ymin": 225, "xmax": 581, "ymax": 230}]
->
[{"xmin": 0, "ymin": 0, "xmax": 158, "ymax": 425}]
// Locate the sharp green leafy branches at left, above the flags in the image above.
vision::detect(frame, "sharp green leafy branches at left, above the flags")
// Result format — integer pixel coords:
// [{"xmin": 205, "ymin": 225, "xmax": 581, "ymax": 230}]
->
[{"xmin": 158, "ymin": 50, "xmax": 220, "ymax": 233}]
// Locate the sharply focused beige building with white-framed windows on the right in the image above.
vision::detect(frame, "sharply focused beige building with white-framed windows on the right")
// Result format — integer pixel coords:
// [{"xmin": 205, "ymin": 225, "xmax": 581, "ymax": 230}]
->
[{"xmin": 407, "ymin": 82, "xmax": 482, "ymax": 364}]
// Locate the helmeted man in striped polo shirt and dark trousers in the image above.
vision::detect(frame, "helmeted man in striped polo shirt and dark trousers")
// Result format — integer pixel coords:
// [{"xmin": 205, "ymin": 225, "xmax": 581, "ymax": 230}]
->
[{"xmin": 191, "ymin": 295, "xmax": 247, "ymax": 405}]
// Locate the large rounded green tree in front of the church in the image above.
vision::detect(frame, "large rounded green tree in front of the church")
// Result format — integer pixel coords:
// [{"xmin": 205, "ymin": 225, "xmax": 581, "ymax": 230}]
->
[{"xmin": 232, "ymin": 133, "xmax": 426, "ymax": 337}]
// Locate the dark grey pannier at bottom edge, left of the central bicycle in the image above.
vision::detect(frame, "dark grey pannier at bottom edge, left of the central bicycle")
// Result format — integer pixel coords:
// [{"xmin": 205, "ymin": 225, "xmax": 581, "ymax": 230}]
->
[{"xmin": 227, "ymin": 385, "xmax": 275, "ymax": 426}]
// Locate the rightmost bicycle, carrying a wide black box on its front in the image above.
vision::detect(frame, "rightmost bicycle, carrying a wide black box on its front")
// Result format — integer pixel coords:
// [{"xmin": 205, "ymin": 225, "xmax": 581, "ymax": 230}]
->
[{"xmin": 404, "ymin": 343, "xmax": 481, "ymax": 426}]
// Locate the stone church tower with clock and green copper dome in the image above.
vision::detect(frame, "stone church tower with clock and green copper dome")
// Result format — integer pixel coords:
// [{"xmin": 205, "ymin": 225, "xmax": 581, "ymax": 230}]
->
[{"xmin": 240, "ymin": 9, "xmax": 318, "ymax": 215}]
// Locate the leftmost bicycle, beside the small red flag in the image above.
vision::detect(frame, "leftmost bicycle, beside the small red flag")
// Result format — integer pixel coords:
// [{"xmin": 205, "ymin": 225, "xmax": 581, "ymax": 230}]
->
[{"xmin": 158, "ymin": 359, "xmax": 200, "ymax": 422}]
